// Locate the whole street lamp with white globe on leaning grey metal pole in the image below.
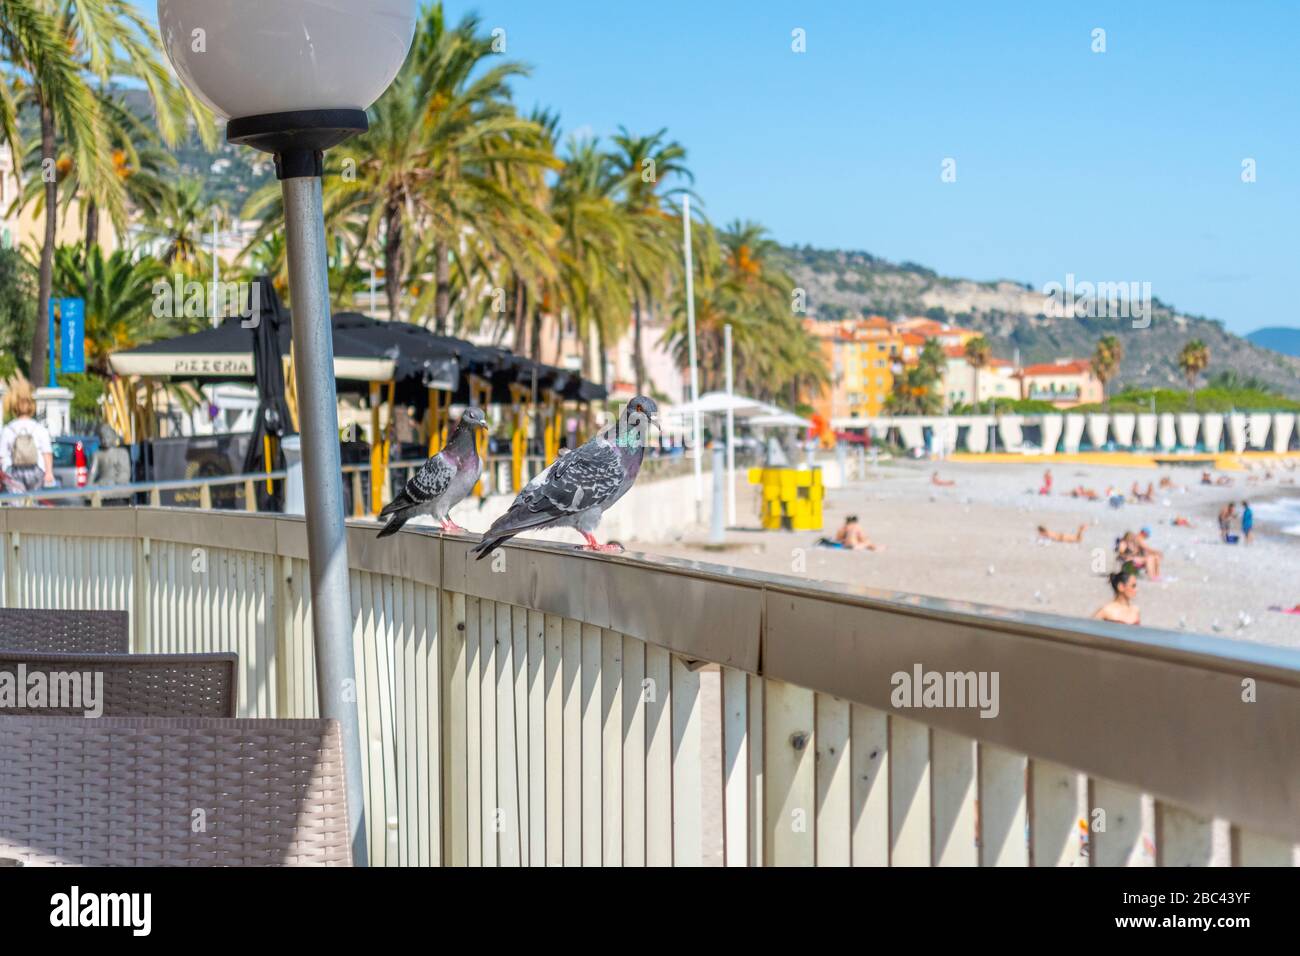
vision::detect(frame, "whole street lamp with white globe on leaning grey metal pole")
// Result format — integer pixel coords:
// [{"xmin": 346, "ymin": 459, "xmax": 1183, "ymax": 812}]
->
[{"xmin": 159, "ymin": 0, "xmax": 416, "ymax": 865}]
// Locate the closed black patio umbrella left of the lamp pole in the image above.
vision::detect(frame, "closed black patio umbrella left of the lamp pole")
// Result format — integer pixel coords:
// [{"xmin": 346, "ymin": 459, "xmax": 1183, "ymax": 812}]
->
[{"xmin": 244, "ymin": 276, "xmax": 293, "ymax": 511}]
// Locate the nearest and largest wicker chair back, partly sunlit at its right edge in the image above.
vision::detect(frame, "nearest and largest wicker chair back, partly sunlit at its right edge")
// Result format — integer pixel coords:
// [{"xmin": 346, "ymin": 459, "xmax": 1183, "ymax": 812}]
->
[{"xmin": 0, "ymin": 717, "xmax": 351, "ymax": 866}]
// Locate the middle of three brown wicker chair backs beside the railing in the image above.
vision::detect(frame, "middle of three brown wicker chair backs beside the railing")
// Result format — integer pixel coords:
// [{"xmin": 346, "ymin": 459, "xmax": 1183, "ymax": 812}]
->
[{"xmin": 0, "ymin": 650, "xmax": 239, "ymax": 717}]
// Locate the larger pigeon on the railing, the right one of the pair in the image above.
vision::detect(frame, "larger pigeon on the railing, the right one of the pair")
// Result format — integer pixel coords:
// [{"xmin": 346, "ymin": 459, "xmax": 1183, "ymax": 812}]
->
[{"xmin": 475, "ymin": 395, "xmax": 659, "ymax": 561}]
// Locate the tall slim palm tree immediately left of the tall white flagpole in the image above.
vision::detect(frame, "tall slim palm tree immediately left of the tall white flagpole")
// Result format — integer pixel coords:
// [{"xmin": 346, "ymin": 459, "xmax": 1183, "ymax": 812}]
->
[{"xmin": 612, "ymin": 126, "xmax": 696, "ymax": 394}]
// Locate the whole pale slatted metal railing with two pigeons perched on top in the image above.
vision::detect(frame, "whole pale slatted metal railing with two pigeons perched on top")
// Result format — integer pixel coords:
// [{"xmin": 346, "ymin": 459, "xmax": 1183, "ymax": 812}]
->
[{"xmin": 0, "ymin": 509, "xmax": 1300, "ymax": 865}]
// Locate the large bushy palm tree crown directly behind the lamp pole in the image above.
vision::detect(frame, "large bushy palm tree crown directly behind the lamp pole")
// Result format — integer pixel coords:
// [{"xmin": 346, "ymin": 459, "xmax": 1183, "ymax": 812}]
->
[{"xmin": 244, "ymin": 4, "xmax": 555, "ymax": 332}]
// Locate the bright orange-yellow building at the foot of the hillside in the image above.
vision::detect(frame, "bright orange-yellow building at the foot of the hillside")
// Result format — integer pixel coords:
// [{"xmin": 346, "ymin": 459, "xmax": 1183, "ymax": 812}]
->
[{"xmin": 805, "ymin": 316, "xmax": 904, "ymax": 421}]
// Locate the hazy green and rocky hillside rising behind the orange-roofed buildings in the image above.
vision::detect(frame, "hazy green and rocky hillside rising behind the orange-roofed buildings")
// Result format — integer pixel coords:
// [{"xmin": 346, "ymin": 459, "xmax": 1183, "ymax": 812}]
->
[{"xmin": 784, "ymin": 246, "xmax": 1300, "ymax": 398}]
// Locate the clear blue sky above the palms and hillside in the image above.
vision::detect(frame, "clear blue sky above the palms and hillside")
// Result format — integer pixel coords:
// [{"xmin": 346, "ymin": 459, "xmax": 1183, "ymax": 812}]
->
[{"xmin": 140, "ymin": 0, "xmax": 1300, "ymax": 332}]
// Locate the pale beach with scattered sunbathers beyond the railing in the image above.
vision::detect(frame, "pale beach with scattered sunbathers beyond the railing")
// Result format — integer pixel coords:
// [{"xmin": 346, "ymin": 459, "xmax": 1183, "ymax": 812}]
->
[{"xmin": 639, "ymin": 462, "xmax": 1300, "ymax": 646}]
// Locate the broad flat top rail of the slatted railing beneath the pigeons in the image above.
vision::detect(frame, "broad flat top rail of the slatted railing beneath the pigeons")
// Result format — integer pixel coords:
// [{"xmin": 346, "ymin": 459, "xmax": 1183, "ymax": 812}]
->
[{"xmin": 10, "ymin": 507, "xmax": 1300, "ymax": 839}]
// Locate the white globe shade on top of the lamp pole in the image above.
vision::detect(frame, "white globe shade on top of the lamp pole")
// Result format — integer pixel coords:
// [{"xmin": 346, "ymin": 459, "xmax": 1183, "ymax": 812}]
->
[{"xmin": 159, "ymin": 0, "xmax": 417, "ymax": 118}]
